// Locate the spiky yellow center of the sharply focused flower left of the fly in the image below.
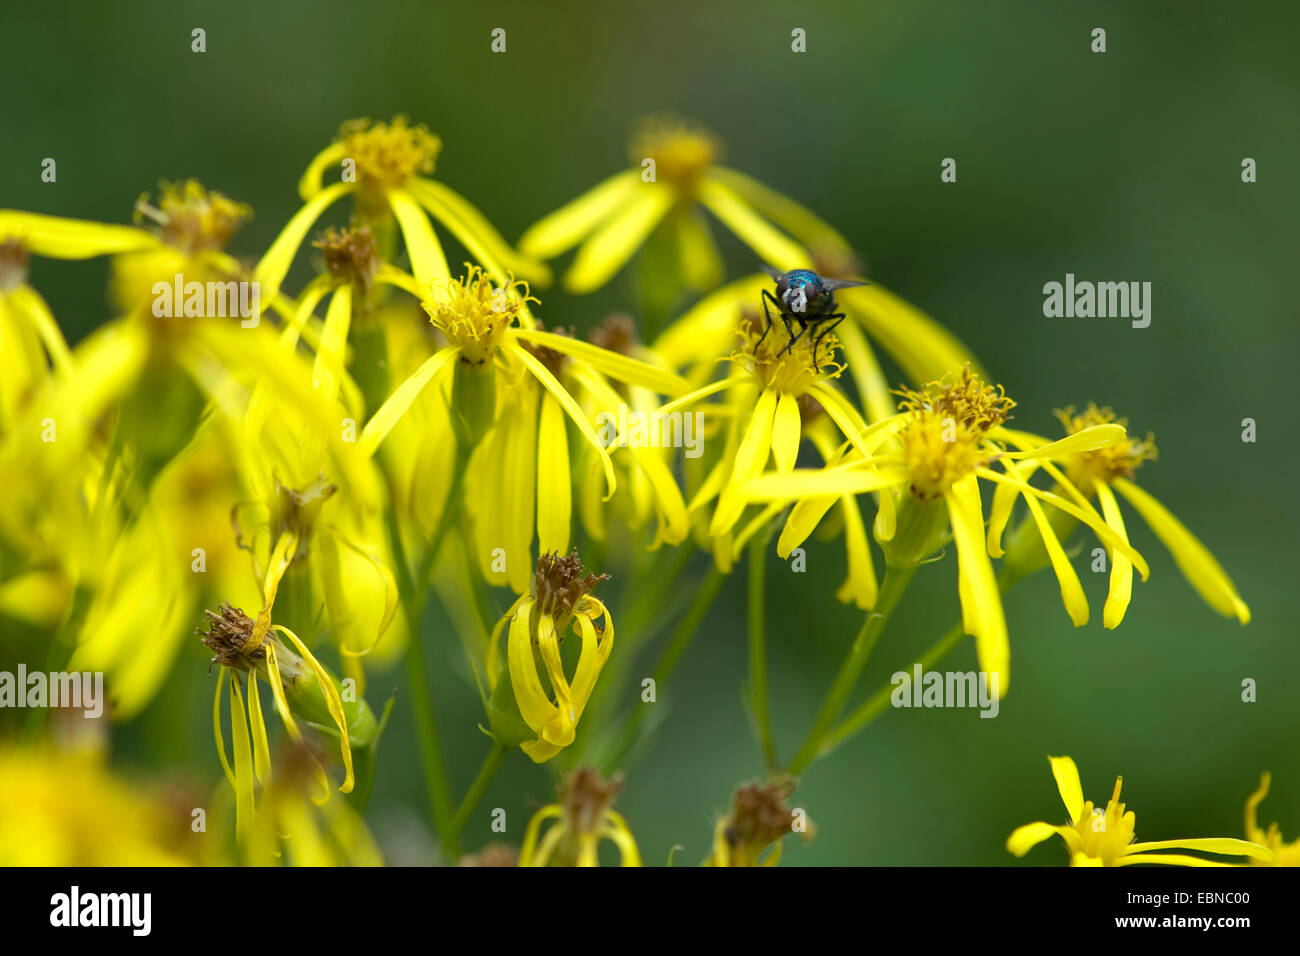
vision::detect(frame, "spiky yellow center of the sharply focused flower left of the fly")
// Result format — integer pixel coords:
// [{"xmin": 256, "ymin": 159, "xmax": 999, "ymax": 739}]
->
[{"xmin": 421, "ymin": 263, "xmax": 537, "ymax": 365}]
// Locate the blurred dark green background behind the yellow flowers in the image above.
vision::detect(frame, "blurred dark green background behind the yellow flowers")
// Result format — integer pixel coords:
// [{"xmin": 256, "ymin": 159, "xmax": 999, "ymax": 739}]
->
[{"xmin": 0, "ymin": 0, "xmax": 1300, "ymax": 865}]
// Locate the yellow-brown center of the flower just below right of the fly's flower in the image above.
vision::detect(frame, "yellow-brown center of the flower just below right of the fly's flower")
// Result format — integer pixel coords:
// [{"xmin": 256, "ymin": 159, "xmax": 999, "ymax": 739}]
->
[{"xmin": 894, "ymin": 365, "xmax": 1015, "ymax": 501}]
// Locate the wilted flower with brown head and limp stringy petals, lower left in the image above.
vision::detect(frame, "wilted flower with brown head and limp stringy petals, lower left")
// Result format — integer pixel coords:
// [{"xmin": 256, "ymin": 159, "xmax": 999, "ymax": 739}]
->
[{"xmin": 198, "ymin": 605, "xmax": 376, "ymax": 843}]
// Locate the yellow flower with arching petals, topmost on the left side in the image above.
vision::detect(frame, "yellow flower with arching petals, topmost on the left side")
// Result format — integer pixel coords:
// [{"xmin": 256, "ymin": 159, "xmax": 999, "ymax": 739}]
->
[{"xmin": 255, "ymin": 116, "xmax": 550, "ymax": 303}]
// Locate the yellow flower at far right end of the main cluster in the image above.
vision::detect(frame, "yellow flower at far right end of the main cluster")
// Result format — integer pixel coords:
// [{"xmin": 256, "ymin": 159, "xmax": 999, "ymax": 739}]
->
[{"xmin": 1053, "ymin": 405, "xmax": 1251, "ymax": 627}]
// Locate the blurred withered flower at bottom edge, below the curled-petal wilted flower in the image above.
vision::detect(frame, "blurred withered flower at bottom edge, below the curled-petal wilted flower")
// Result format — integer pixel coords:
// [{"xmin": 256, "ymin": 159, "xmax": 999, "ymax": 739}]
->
[{"xmin": 519, "ymin": 767, "xmax": 641, "ymax": 866}]
